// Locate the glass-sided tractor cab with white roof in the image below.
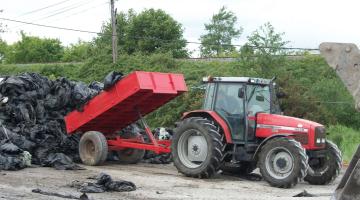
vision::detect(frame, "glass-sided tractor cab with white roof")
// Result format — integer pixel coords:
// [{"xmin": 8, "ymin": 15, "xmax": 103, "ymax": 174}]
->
[{"xmin": 203, "ymin": 77, "xmax": 280, "ymax": 143}]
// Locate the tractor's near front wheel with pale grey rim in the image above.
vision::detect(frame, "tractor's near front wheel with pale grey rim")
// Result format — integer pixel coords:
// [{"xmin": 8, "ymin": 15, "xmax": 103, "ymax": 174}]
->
[{"xmin": 258, "ymin": 137, "xmax": 309, "ymax": 188}]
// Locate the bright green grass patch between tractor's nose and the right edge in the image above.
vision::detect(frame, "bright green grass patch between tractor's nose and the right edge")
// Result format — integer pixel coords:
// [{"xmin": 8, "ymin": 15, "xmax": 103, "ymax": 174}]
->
[{"xmin": 328, "ymin": 125, "xmax": 360, "ymax": 162}]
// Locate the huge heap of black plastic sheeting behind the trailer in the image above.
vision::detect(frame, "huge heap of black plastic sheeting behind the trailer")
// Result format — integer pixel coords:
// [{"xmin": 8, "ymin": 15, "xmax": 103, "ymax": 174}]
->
[{"xmin": 0, "ymin": 72, "xmax": 122, "ymax": 170}]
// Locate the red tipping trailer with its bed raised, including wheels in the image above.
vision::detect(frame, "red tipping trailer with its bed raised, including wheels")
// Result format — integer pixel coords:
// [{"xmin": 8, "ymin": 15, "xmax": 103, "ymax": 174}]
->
[{"xmin": 65, "ymin": 71, "xmax": 187, "ymax": 165}]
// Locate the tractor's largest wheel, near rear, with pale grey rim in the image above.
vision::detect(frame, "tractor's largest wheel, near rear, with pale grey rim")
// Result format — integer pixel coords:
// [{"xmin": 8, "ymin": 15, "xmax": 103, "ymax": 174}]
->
[{"xmin": 171, "ymin": 117, "xmax": 224, "ymax": 178}]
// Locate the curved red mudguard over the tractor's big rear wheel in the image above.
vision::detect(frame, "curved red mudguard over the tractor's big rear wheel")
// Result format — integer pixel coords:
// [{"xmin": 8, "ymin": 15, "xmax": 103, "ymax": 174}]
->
[{"xmin": 181, "ymin": 110, "xmax": 233, "ymax": 143}]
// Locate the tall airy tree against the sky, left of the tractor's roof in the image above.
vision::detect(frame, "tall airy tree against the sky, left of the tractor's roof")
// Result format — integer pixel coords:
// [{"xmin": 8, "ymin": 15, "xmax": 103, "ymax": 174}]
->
[{"xmin": 200, "ymin": 7, "xmax": 243, "ymax": 57}]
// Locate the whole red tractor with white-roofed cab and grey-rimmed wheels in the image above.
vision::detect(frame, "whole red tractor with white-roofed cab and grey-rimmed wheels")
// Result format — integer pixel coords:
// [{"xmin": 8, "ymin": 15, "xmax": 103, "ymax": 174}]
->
[{"xmin": 171, "ymin": 77, "xmax": 342, "ymax": 188}]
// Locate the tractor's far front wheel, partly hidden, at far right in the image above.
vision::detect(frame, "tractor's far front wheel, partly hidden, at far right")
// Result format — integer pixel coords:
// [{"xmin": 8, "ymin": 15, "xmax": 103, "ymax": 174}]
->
[{"xmin": 305, "ymin": 141, "xmax": 342, "ymax": 185}]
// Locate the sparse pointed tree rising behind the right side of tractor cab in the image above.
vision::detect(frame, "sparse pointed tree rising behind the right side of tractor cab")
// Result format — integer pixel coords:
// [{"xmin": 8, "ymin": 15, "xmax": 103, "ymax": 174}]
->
[{"xmin": 240, "ymin": 22, "xmax": 289, "ymax": 74}]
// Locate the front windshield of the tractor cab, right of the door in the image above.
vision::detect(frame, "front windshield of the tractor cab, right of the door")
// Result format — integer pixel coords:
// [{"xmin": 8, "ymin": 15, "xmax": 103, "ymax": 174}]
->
[{"xmin": 246, "ymin": 85, "xmax": 271, "ymax": 116}]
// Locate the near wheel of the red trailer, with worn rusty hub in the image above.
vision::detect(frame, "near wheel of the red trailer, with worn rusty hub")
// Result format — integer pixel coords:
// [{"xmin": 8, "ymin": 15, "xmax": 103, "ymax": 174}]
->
[{"xmin": 79, "ymin": 131, "xmax": 108, "ymax": 165}]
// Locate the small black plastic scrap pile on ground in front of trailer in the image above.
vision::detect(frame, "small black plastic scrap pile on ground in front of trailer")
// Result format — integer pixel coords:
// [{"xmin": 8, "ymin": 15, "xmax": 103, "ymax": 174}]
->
[{"xmin": 70, "ymin": 173, "xmax": 136, "ymax": 193}]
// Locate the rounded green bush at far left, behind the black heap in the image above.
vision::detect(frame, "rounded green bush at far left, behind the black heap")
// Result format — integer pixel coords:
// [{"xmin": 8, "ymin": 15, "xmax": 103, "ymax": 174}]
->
[{"xmin": 5, "ymin": 32, "xmax": 64, "ymax": 63}]
